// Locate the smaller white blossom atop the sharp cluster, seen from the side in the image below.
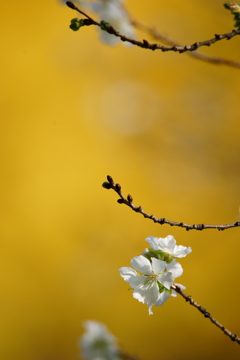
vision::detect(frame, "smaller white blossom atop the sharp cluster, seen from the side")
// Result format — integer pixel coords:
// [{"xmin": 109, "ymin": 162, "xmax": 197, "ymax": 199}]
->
[{"xmin": 146, "ymin": 235, "xmax": 192, "ymax": 258}]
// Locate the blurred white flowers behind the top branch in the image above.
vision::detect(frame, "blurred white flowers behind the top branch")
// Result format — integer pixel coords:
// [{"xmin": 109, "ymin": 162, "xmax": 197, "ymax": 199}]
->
[{"xmin": 62, "ymin": 0, "xmax": 134, "ymax": 45}]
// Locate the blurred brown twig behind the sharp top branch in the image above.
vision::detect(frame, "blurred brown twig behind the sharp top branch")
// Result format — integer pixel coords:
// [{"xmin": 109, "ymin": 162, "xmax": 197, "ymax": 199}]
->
[{"xmin": 129, "ymin": 15, "xmax": 240, "ymax": 68}]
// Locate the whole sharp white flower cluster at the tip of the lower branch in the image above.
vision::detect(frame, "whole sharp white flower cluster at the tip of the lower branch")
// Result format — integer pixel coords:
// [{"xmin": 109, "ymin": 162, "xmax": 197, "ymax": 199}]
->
[{"xmin": 119, "ymin": 235, "xmax": 192, "ymax": 315}]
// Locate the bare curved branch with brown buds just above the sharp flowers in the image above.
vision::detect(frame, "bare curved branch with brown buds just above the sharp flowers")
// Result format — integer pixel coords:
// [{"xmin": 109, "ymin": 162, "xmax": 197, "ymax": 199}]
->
[{"xmin": 102, "ymin": 175, "xmax": 240, "ymax": 231}]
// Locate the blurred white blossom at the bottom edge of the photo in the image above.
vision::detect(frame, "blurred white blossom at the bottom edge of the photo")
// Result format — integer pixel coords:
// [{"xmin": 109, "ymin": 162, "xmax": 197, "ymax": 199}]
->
[{"xmin": 80, "ymin": 320, "xmax": 120, "ymax": 360}]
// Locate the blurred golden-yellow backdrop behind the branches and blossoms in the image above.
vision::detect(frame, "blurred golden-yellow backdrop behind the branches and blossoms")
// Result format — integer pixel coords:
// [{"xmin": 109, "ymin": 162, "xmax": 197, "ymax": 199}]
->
[{"xmin": 0, "ymin": 0, "xmax": 240, "ymax": 360}]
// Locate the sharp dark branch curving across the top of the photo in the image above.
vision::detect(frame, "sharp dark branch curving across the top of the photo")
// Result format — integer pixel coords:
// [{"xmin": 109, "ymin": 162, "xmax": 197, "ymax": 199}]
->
[{"xmin": 66, "ymin": 1, "xmax": 240, "ymax": 54}]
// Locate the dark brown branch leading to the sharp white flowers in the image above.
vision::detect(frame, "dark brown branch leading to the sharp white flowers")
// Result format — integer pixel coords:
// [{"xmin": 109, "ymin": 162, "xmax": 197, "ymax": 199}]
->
[{"xmin": 171, "ymin": 284, "xmax": 240, "ymax": 344}]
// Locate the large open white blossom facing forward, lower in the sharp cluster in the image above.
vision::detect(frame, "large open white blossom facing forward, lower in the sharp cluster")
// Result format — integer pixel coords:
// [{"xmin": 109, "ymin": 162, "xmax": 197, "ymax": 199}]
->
[{"xmin": 119, "ymin": 255, "xmax": 183, "ymax": 315}]
